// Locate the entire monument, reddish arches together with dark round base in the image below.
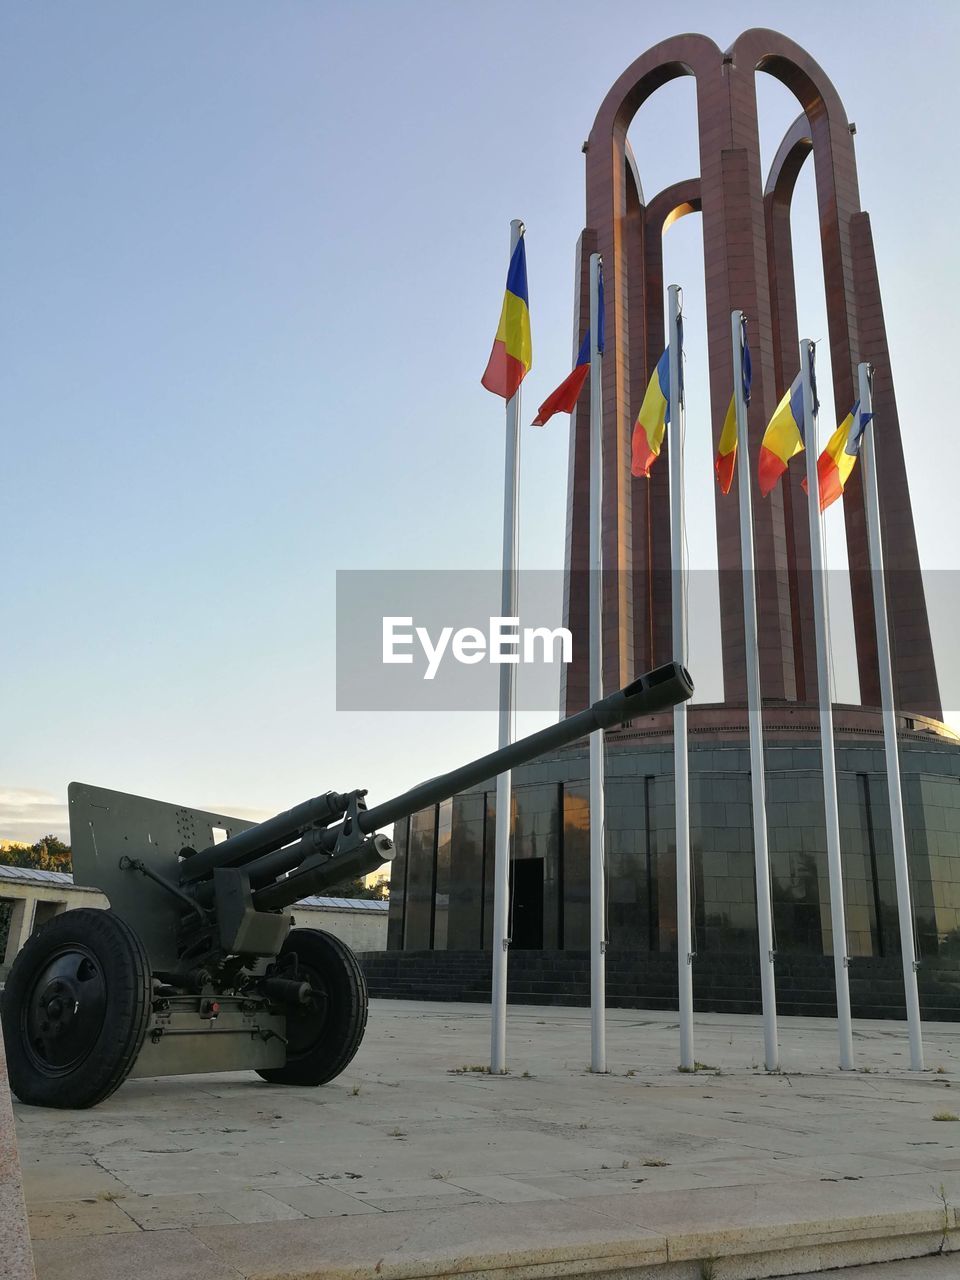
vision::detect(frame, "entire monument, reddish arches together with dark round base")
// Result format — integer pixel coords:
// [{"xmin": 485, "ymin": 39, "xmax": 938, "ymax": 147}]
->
[{"xmin": 378, "ymin": 29, "xmax": 960, "ymax": 998}]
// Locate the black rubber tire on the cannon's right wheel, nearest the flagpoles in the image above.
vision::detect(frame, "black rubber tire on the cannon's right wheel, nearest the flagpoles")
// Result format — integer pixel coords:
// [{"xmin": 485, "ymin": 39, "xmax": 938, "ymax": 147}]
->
[{"xmin": 257, "ymin": 929, "xmax": 367, "ymax": 1084}]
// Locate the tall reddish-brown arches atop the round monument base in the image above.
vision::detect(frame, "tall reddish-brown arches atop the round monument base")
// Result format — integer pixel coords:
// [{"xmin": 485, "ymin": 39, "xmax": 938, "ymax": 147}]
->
[{"xmin": 564, "ymin": 29, "xmax": 942, "ymax": 719}]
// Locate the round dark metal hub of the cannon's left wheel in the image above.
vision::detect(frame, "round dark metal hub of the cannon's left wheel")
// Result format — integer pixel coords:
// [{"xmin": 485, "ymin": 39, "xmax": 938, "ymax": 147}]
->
[{"xmin": 22, "ymin": 946, "xmax": 106, "ymax": 1075}]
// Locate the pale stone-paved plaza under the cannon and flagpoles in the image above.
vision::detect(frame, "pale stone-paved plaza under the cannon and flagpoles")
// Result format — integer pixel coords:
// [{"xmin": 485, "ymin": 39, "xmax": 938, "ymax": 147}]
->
[{"xmin": 15, "ymin": 1001, "xmax": 960, "ymax": 1280}]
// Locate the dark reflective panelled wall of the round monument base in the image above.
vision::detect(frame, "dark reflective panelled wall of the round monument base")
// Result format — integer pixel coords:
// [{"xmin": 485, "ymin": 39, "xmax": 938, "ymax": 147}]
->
[{"xmin": 388, "ymin": 739, "xmax": 960, "ymax": 957}]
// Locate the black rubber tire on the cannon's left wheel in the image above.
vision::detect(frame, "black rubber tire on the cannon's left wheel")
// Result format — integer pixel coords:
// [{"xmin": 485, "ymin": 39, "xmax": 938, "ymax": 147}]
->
[{"xmin": 0, "ymin": 908, "xmax": 151, "ymax": 1108}]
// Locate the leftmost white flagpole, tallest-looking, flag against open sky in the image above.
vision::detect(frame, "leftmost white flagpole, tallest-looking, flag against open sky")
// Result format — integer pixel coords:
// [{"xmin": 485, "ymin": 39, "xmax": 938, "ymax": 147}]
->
[{"xmin": 490, "ymin": 218, "xmax": 524, "ymax": 1074}]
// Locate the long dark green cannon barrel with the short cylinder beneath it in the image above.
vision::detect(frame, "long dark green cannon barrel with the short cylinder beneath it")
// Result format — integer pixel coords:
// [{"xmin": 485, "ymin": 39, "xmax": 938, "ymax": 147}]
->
[{"xmin": 248, "ymin": 662, "xmax": 694, "ymax": 911}]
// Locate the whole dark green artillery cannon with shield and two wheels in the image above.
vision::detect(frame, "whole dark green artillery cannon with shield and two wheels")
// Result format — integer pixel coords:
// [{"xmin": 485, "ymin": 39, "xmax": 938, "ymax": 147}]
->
[{"xmin": 0, "ymin": 663, "xmax": 692, "ymax": 1107}]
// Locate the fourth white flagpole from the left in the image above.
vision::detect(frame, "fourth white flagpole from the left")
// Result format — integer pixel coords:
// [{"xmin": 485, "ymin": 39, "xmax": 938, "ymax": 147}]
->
[{"xmin": 730, "ymin": 311, "xmax": 780, "ymax": 1071}]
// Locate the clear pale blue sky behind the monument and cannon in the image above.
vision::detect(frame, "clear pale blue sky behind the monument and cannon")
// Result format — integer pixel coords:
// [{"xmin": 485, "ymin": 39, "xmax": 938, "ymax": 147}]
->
[{"xmin": 0, "ymin": 0, "xmax": 960, "ymax": 840}]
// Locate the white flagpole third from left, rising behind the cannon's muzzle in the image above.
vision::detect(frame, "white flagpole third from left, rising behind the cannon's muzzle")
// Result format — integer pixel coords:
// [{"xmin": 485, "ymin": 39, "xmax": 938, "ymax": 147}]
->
[{"xmin": 667, "ymin": 284, "xmax": 695, "ymax": 1071}]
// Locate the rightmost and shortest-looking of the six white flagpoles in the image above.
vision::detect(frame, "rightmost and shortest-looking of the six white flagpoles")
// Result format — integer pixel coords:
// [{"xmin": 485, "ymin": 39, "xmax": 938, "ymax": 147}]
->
[{"xmin": 854, "ymin": 365, "xmax": 923, "ymax": 1071}]
